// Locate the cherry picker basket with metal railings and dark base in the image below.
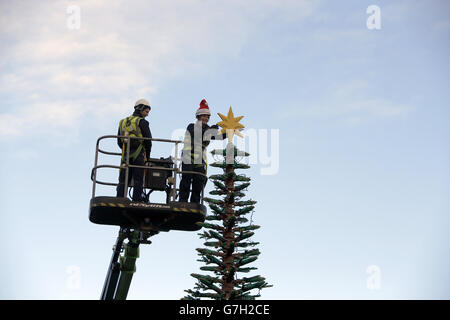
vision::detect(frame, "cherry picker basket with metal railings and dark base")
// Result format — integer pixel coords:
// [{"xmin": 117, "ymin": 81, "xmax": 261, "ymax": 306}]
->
[{"xmin": 89, "ymin": 135, "xmax": 206, "ymax": 231}]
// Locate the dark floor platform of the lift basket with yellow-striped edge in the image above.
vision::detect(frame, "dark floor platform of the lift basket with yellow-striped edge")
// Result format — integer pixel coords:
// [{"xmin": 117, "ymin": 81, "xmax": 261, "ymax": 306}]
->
[{"xmin": 89, "ymin": 197, "xmax": 206, "ymax": 231}]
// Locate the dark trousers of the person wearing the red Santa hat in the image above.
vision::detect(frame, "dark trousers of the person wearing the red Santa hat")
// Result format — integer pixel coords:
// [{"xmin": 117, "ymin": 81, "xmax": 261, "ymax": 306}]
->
[{"xmin": 179, "ymin": 163, "xmax": 207, "ymax": 203}]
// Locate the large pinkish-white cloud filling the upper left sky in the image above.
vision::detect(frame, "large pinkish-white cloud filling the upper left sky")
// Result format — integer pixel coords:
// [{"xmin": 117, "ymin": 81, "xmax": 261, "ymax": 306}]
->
[{"xmin": 0, "ymin": 0, "xmax": 315, "ymax": 137}]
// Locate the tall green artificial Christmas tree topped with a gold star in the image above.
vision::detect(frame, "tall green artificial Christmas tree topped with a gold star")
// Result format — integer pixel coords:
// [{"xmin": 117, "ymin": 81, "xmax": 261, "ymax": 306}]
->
[{"xmin": 185, "ymin": 107, "xmax": 271, "ymax": 300}]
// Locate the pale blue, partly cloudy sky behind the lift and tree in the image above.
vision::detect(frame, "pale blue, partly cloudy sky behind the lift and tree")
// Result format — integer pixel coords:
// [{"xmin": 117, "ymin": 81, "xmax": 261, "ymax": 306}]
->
[{"xmin": 0, "ymin": 0, "xmax": 450, "ymax": 300}]
